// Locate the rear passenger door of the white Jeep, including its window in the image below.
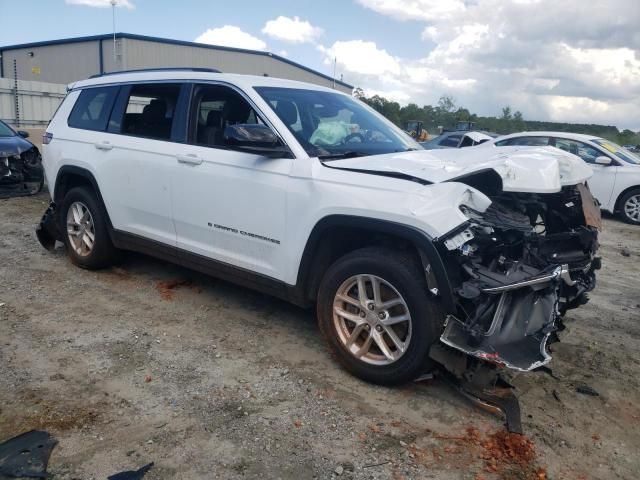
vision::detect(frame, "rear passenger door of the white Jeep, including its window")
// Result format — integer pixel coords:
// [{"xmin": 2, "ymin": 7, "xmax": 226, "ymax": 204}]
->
[{"xmin": 95, "ymin": 82, "xmax": 188, "ymax": 246}]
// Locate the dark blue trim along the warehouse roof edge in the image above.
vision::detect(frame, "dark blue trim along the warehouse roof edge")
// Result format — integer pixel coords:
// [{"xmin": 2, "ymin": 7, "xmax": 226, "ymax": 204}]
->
[{"xmin": 0, "ymin": 32, "xmax": 354, "ymax": 88}]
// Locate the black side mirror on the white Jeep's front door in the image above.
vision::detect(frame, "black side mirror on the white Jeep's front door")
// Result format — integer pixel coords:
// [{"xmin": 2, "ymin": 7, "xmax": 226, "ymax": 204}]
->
[{"xmin": 224, "ymin": 123, "xmax": 289, "ymax": 157}]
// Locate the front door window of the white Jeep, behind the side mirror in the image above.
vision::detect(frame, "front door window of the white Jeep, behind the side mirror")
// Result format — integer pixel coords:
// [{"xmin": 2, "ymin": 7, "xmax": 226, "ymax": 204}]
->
[{"xmin": 189, "ymin": 85, "xmax": 263, "ymax": 148}]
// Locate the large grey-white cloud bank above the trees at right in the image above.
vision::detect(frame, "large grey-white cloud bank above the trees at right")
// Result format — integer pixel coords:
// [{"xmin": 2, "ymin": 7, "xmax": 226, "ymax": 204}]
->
[{"xmin": 344, "ymin": 0, "xmax": 640, "ymax": 130}]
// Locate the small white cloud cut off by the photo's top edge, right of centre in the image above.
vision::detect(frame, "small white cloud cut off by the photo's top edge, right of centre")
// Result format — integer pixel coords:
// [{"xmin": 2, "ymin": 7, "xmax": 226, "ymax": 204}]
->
[{"xmin": 358, "ymin": 0, "xmax": 466, "ymax": 21}]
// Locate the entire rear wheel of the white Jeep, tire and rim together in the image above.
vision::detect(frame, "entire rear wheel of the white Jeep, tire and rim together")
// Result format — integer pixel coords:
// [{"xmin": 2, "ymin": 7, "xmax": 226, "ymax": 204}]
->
[{"xmin": 59, "ymin": 187, "xmax": 118, "ymax": 270}]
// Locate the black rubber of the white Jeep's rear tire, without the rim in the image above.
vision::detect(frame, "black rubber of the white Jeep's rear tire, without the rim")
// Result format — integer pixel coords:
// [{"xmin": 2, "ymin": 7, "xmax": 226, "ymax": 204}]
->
[{"xmin": 59, "ymin": 187, "xmax": 113, "ymax": 269}]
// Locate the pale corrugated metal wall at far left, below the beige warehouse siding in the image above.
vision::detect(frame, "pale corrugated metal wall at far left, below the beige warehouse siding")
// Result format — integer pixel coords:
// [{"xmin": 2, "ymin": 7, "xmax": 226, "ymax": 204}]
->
[{"xmin": 0, "ymin": 78, "xmax": 66, "ymax": 127}]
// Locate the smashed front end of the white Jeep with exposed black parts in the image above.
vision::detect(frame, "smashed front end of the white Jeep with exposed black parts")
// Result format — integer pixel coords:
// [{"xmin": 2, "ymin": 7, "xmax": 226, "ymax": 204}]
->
[{"xmin": 432, "ymin": 179, "xmax": 601, "ymax": 431}]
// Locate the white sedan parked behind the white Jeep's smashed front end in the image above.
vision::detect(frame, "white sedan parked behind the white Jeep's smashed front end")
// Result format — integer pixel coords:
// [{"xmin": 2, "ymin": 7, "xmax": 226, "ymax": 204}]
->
[{"xmin": 491, "ymin": 132, "xmax": 640, "ymax": 225}]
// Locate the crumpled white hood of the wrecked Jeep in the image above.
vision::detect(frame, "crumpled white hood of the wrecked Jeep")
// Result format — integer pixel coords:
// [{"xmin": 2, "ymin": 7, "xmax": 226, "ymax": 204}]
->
[{"xmin": 331, "ymin": 144, "xmax": 593, "ymax": 193}]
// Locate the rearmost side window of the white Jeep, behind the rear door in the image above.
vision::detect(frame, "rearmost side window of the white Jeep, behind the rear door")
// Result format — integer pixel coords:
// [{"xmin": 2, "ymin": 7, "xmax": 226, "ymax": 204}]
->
[{"xmin": 67, "ymin": 87, "xmax": 119, "ymax": 131}]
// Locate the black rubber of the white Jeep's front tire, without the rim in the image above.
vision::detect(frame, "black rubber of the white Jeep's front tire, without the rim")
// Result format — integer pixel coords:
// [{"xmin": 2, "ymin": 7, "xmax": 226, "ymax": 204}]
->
[{"xmin": 317, "ymin": 249, "xmax": 443, "ymax": 385}]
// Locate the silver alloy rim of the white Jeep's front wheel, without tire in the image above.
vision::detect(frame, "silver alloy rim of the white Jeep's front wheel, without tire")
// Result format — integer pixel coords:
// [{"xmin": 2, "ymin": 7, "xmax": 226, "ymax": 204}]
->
[{"xmin": 333, "ymin": 274, "xmax": 411, "ymax": 365}]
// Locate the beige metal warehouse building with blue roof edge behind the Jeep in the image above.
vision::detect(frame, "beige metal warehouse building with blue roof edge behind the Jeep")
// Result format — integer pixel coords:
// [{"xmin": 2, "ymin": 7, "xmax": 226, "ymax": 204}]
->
[{"xmin": 0, "ymin": 33, "xmax": 353, "ymax": 93}]
